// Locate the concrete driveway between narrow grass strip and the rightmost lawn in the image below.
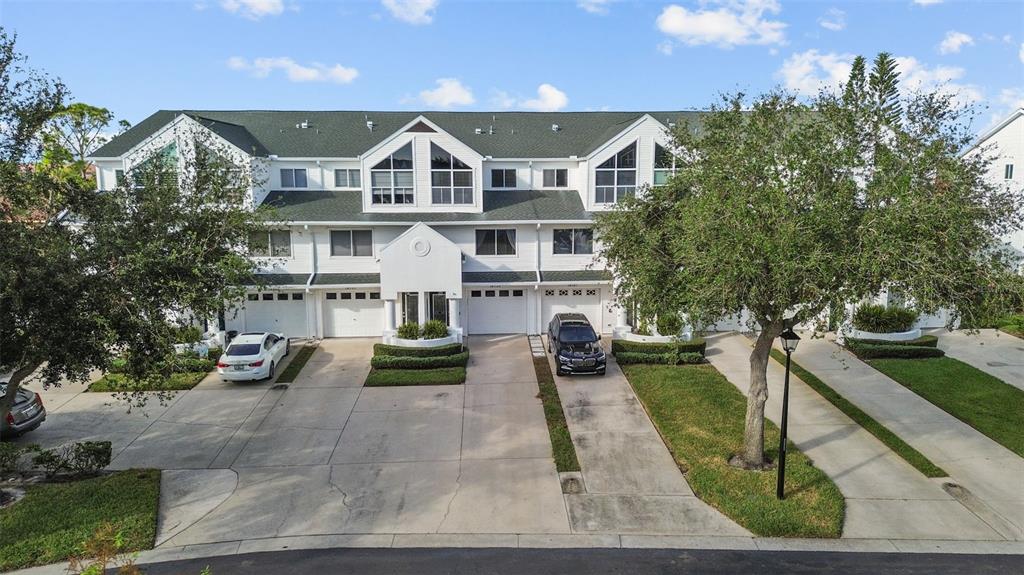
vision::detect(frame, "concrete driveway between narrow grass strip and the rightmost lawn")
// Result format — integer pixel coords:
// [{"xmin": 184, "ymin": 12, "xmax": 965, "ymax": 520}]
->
[{"xmin": 794, "ymin": 338, "xmax": 1024, "ymax": 540}]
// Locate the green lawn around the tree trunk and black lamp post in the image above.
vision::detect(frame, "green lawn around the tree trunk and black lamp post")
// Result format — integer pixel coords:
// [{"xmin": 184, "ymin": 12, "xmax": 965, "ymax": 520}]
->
[{"xmin": 622, "ymin": 365, "xmax": 846, "ymax": 537}]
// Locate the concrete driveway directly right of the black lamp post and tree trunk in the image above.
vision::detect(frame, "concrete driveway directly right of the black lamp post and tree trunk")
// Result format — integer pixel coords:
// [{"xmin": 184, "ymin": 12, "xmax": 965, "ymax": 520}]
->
[{"xmin": 708, "ymin": 335, "xmax": 1004, "ymax": 540}]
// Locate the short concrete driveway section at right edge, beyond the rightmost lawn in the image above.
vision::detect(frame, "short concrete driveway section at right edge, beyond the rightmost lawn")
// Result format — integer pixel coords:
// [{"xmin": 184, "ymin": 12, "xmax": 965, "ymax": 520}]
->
[{"xmin": 928, "ymin": 329, "xmax": 1024, "ymax": 390}]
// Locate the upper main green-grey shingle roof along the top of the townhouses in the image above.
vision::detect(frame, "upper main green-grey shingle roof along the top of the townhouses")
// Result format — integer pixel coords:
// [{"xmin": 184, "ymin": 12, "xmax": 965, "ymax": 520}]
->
[{"xmin": 93, "ymin": 109, "xmax": 700, "ymax": 158}]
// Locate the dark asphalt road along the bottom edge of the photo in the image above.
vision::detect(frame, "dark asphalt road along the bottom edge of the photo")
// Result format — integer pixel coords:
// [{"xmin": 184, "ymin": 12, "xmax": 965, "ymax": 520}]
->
[{"xmin": 138, "ymin": 548, "xmax": 1024, "ymax": 575}]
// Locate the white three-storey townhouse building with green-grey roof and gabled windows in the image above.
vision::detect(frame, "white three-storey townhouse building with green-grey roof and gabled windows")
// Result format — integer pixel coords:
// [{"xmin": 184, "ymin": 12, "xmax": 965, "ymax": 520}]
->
[{"xmin": 92, "ymin": 110, "xmax": 695, "ymax": 338}]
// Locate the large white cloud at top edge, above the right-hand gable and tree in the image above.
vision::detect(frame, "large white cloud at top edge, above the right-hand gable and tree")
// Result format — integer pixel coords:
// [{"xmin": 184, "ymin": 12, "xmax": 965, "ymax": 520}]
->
[{"xmin": 656, "ymin": 0, "xmax": 786, "ymax": 48}]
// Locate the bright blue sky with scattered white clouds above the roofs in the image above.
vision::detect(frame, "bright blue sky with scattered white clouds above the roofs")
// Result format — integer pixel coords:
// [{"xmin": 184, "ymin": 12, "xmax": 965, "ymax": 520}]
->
[{"xmin": 0, "ymin": 0, "xmax": 1024, "ymax": 127}]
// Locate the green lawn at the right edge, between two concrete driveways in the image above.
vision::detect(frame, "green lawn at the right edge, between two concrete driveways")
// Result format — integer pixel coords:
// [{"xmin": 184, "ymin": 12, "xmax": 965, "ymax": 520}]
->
[{"xmin": 867, "ymin": 357, "xmax": 1024, "ymax": 457}]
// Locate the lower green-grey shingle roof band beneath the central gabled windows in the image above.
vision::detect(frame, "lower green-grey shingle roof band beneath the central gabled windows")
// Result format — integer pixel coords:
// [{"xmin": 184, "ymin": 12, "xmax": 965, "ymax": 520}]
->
[{"xmin": 263, "ymin": 190, "xmax": 592, "ymax": 223}]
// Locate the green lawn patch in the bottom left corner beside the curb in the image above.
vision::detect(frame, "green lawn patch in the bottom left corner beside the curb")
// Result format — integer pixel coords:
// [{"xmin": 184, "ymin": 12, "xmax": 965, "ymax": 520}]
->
[{"xmin": 0, "ymin": 470, "xmax": 160, "ymax": 571}]
